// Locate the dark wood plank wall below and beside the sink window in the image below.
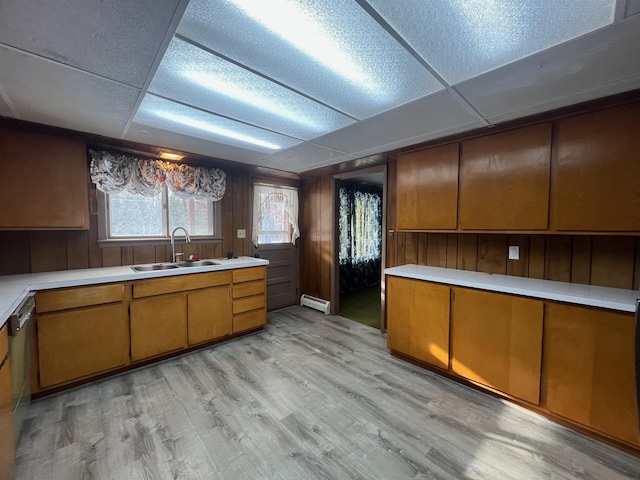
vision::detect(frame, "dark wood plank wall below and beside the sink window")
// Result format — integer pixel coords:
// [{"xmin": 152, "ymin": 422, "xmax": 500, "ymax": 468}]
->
[{"xmin": 0, "ymin": 168, "xmax": 251, "ymax": 275}]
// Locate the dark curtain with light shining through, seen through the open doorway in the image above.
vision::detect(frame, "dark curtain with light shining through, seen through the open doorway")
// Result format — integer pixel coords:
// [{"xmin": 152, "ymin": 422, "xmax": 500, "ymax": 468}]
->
[{"xmin": 338, "ymin": 185, "xmax": 382, "ymax": 293}]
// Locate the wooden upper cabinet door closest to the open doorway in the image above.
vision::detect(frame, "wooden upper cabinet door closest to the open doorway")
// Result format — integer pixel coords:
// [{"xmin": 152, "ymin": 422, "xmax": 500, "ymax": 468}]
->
[{"xmin": 397, "ymin": 143, "xmax": 459, "ymax": 230}]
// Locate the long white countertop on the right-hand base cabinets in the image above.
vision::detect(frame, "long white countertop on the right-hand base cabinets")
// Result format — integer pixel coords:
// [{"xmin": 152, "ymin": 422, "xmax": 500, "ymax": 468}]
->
[{"xmin": 384, "ymin": 265, "xmax": 640, "ymax": 313}]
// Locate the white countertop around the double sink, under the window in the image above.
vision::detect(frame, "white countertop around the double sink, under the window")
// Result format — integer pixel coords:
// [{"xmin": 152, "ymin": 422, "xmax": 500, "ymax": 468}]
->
[{"xmin": 0, "ymin": 257, "xmax": 269, "ymax": 328}]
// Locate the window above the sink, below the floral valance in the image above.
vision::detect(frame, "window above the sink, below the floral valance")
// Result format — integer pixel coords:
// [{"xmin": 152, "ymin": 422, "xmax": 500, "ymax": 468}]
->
[{"xmin": 98, "ymin": 186, "xmax": 220, "ymax": 240}]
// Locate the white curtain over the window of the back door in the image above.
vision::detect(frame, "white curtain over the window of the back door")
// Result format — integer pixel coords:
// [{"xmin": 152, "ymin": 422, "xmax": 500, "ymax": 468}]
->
[{"xmin": 251, "ymin": 184, "xmax": 300, "ymax": 246}]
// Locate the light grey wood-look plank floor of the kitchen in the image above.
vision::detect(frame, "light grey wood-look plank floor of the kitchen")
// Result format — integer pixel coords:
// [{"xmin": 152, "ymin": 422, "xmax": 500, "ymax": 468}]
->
[{"xmin": 14, "ymin": 307, "xmax": 640, "ymax": 480}]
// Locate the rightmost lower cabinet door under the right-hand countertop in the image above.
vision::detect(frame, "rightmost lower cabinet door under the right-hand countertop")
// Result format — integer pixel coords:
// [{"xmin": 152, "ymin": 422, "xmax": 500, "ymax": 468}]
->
[{"xmin": 543, "ymin": 303, "xmax": 639, "ymax": 445}]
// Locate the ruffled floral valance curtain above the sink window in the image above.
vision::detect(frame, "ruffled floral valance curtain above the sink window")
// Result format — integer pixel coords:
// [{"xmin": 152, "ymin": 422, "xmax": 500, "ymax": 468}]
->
[{"xmin": 89, "ymin": 150, "xmax": 226, "ymax": 201}]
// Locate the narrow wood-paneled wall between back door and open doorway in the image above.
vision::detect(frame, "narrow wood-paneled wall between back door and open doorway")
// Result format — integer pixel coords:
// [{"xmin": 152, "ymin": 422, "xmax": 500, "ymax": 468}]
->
[{"xmin": 299, "ymin": 175, "xmax": 335, "ymax": 300}]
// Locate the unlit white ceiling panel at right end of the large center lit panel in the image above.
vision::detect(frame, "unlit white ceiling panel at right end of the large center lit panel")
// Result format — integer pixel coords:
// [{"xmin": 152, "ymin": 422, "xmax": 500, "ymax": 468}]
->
[{"xmin": 314, "ymin": 91, "xmax": 484, "ymax": 156}]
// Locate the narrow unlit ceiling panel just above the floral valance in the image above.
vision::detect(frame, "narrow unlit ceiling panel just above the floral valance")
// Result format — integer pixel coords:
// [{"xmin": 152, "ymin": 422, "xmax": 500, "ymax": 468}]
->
[{"xmin": 126, "ymin": 123, "xmax": 264, "ymax": 163}]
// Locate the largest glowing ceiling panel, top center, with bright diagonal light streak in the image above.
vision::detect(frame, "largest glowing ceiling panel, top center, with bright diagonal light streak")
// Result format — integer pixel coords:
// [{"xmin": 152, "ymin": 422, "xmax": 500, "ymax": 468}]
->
[{"xmin": 178, "ymin": 0, "xmax": 443, "ymax": 119}]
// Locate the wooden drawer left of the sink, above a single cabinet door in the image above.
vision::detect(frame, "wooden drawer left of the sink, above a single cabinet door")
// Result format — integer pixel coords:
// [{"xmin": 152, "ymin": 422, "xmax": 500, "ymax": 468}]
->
[{"xmin": 36, "ymin": 283, "xmax": 124, "ymax": 313}]
